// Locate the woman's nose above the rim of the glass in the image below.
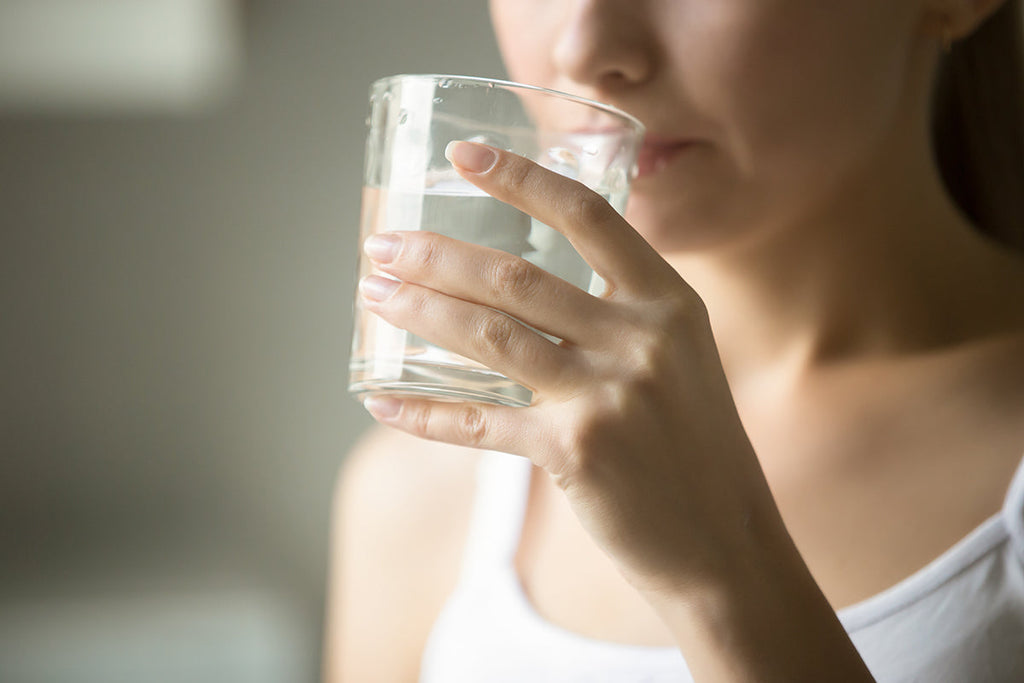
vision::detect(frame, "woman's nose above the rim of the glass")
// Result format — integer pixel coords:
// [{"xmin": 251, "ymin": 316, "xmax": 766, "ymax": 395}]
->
[{"xmin": 552, "ymin": 0, "xmax": 656, "ymax": 91}]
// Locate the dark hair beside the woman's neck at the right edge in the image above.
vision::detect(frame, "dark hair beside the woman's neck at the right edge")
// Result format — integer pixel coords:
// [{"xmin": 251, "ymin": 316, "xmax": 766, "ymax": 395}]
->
[{"xmin": 932, "ymin": 0, "xmax": 1024, "ymax": 250}]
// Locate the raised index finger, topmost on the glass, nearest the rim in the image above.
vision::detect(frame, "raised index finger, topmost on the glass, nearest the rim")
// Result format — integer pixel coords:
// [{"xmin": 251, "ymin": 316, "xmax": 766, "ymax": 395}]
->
[{"xmin": 446, "ymin": 141, "xmax": 675, "ymax": 292}]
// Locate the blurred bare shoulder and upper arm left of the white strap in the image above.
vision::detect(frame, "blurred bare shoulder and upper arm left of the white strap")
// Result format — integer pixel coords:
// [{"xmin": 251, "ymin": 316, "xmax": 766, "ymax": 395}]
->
[{"xmin": 325, "ymin": 426, "xmax": 479, "ymax": 683}]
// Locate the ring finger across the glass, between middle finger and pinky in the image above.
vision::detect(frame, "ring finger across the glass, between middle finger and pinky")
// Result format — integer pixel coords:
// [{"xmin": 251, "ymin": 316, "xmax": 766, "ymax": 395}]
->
[{"xmin": 359, "ymin": 275, "xmax": 580, "ymax": 393}]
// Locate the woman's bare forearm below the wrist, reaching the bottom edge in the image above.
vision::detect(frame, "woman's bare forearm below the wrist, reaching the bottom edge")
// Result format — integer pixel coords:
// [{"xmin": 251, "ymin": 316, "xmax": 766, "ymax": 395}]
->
[{"xmin": 645, "ymin": 509, "xmax": 873, "ymax": 683}]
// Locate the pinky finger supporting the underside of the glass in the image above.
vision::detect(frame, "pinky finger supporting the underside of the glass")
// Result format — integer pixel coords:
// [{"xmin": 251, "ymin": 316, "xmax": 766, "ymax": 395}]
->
[{"xmin": 362, "ymin": 396, "xmax": 535, "ymax": 456}]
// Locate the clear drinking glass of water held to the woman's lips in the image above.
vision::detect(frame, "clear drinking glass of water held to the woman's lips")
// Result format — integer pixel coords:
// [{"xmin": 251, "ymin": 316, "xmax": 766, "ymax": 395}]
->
[{"xmin": 349, "ymin": 75, "xmax": 643, "ymax": 405}]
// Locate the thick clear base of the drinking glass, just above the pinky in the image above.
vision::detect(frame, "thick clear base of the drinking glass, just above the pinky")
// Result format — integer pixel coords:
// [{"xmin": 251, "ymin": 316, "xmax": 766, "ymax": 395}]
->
[{"xmin": 348, "ymin": 358, "xmax": 534, "ymax": 408}]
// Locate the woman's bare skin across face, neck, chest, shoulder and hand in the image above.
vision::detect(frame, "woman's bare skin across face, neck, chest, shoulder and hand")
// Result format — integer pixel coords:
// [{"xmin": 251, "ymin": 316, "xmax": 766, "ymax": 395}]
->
[{"xmin": 328, "ymin": 0, "xmax": 1024, "ymax": 681}]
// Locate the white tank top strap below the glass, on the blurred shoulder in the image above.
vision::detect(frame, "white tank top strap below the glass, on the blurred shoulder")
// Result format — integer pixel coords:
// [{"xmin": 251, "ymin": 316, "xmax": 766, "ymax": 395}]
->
[{"xmin": 462, "ymin": 451, "xmax": 532, "ymax": 581}]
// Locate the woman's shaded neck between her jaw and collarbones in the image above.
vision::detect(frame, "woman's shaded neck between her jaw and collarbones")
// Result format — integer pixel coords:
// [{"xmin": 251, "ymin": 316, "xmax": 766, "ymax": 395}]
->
[{"xmin": 667, "ymin": 137, "xmax": 1024, "ymax": 389}]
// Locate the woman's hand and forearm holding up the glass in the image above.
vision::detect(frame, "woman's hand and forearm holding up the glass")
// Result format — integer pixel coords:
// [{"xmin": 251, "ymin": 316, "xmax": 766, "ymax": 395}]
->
[{"xmin": 360, "ymin": 143, "xmax": 870, "ymax": 683}]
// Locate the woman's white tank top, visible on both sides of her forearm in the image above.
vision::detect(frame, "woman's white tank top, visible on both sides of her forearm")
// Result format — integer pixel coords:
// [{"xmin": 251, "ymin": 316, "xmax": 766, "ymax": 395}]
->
[{"xmin": 420, "ymin": 453, "xmax": 1024, "ymax": 683}]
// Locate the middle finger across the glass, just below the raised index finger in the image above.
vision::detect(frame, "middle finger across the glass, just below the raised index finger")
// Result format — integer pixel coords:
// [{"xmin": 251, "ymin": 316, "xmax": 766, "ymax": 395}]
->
[{"xmin": 366, "ymin": 230, "xmax": 608, "ymax": 344}]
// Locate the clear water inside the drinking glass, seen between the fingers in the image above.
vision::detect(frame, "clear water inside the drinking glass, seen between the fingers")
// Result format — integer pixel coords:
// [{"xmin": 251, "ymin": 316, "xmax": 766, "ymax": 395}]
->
[{"xmin": 349, "ymin": 180, "xmax": 626, "ymax": 405}]
